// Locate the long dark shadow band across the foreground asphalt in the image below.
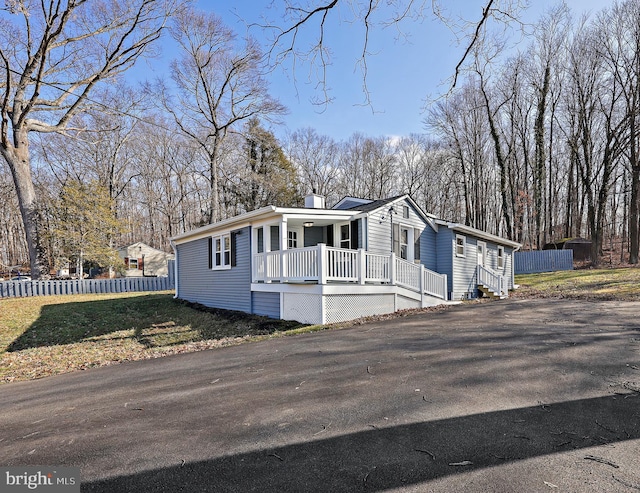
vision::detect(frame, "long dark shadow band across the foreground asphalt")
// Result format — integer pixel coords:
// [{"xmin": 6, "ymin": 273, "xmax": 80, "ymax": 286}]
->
[{"xmin": 82, "ymin": 392, "xmax": 640, "ymax": 492}]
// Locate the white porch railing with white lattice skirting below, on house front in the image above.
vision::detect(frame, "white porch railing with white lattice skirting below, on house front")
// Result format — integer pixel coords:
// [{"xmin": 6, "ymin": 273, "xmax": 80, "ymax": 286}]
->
[{"xmin": 251, "ymin": 243, "xmax": 451, "ymax": 324}]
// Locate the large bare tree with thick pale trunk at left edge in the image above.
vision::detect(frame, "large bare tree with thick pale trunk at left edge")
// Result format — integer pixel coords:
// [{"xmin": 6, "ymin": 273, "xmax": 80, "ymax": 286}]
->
[{"xmin": 0, "ymin": 0, "xmax": 180, "ymax": 279}]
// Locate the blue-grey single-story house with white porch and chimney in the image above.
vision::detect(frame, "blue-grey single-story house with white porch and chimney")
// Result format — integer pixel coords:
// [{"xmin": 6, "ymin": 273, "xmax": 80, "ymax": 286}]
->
[{"xmin": 172, "ymin": 195, "xmax": 520, "ymax": 324}]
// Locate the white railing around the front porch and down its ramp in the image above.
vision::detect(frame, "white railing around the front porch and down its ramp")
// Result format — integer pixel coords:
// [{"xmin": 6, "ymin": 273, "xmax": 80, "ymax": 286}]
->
[{"xmin": 252, "ymin": 244, "xmax": 448, "ymax": 300}]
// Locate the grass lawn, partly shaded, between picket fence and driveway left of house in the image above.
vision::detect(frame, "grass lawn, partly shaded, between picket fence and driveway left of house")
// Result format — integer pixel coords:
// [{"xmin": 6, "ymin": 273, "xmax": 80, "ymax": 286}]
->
[{"xmin": 0, "ymin": 292, "xmax": 305, "ymax": 383}]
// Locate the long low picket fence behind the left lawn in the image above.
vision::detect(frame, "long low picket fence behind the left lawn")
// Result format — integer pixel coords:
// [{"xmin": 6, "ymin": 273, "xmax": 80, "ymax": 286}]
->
[{"xmin": 0, "ymin": 276, "xmax": 174, "ymax": 298}]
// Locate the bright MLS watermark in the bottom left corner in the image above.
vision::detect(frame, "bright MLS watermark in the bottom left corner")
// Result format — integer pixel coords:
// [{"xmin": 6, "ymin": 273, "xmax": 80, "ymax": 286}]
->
[{"xmin": 0, "ymin": 466, "xmax": 80, "ymax": 493}]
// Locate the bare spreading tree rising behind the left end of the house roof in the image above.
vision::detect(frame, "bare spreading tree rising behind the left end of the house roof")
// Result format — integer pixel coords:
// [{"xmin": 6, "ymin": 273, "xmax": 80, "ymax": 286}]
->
[{"xmin": 156, "ymin": 9, "xmax": 286, "ymax": 222}]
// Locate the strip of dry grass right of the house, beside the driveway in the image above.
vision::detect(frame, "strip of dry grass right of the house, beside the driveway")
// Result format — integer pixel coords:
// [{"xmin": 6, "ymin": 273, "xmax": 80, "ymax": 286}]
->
[{"xmin": 515, "ymin": 267, "xmax": 640, "ymax": 301}]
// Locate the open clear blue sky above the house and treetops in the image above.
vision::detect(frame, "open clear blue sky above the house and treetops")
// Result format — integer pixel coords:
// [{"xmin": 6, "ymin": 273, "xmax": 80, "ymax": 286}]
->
[{"xmin": 172, "ymin": 0, "xmax": 612, "ymax": 140}]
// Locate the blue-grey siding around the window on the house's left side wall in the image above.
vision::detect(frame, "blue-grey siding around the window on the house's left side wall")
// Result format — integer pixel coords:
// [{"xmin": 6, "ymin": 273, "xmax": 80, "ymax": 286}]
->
[{"xmin": 176, "ymin": 228, "xmax": 251, "ymax": 313}]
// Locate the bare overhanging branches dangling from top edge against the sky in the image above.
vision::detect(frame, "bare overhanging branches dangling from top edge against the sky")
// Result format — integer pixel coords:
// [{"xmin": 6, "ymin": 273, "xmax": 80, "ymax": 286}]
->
[{"xmin": 260, "ymin": 0, "xmax": 526, "ymax": 104}]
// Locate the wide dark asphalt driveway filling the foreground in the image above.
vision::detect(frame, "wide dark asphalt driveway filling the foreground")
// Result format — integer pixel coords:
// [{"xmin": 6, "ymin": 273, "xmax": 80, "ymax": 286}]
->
[{"xmin": 0, "ymin": 300, "xmax": 640, "ymax": 492}]
